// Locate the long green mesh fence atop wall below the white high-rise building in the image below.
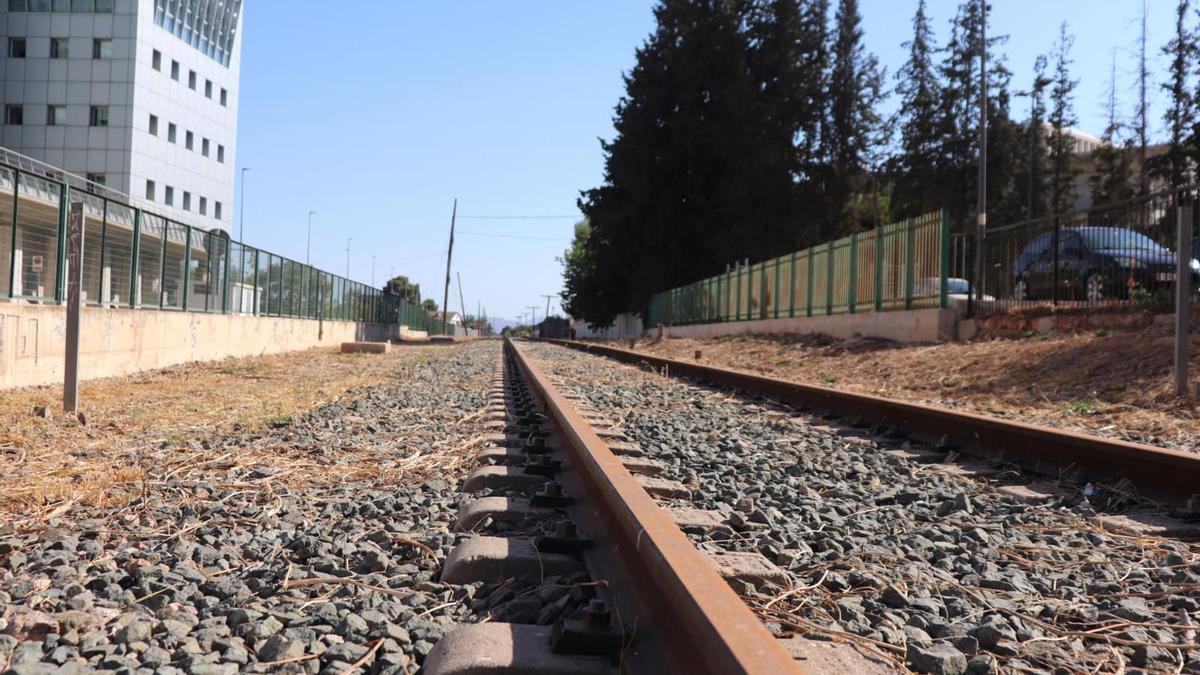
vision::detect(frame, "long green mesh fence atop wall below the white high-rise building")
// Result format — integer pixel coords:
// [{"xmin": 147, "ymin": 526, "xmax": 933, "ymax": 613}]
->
[{"xmin": 0, "ymin": 157, "xmax": 440, "ymax": 331}]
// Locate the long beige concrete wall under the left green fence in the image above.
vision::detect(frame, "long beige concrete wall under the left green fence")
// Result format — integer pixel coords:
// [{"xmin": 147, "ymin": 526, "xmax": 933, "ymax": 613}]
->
[{"xmin": 0, "ymin": 303, "xmax": 398, "ymax": 389}]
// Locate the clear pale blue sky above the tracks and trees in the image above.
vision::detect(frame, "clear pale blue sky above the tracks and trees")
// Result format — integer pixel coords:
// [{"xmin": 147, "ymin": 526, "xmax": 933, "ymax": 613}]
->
[{"xmin": 233, "ymin": 0, "xmax": 1174, "ymax": 318}]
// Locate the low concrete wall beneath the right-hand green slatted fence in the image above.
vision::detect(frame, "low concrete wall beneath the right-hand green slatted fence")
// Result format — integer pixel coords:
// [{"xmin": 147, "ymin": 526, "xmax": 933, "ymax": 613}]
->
[{"xmin": 646, "ymin": 309, "xmax": 958, "ymax": 342}]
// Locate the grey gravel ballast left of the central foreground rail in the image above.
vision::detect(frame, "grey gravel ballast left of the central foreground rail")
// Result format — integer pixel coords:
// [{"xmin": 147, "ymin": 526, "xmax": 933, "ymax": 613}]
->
[{"xmin": 0, "ymin": 341, "xmax": 559, "ymax": 674}]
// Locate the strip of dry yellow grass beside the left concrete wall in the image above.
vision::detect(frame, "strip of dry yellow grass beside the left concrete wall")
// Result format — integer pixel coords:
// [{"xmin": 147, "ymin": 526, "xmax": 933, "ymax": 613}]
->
[{"xmin": 0, "ymin": 347, "xmax": 477, "ymax": 522}]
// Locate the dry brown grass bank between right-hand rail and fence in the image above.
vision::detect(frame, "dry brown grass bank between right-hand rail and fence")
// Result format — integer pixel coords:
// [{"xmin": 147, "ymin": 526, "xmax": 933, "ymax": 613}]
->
[{"xmin": 636, "ymin": 328, "xmax": 1200, "ymax": 452}]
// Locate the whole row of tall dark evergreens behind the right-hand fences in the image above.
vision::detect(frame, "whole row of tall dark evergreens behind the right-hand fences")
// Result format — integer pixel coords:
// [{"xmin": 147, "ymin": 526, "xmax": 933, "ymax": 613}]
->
[{"xmin": 562, "ymin": 0, "xmax": 1200, "ymax": 325}]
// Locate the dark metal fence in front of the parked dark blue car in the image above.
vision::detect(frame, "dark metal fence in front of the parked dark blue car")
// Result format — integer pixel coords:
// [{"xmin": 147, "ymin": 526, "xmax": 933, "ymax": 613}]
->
[{"xmin": 953, "ymin": 187, "xmax": 1200, "ymax": 315}]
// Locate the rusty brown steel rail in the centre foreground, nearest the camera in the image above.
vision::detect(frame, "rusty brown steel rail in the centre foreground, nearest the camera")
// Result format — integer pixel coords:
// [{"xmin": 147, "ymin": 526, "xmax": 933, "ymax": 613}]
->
[{"xmin": 505, "ymin": 339, "xmax": 802, "ymax": 675}]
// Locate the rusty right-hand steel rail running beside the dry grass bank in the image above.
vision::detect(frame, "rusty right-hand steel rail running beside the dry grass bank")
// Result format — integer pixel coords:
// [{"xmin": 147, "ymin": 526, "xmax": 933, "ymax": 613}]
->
[{"xmin": 545, "ymin": 340, "xmax": 1200, "ymax": 504}]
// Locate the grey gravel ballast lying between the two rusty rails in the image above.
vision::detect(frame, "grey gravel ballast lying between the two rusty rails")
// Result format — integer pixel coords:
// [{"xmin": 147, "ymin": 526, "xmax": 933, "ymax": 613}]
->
[{"xmin": 524, "ymin": 345, "xmax": 1200, "ymax": 674}]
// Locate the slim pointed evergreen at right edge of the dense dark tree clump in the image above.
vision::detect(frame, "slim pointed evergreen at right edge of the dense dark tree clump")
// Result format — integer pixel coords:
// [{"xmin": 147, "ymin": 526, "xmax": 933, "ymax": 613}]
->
[{"xmin": 824, "ymin": 0, "xmax": 883, "ymax": 237}]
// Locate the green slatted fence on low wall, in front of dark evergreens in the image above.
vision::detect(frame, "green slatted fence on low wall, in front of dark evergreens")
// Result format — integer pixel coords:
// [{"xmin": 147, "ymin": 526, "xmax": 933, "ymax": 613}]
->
[{"xmin": 647, "ymin": 209, "xmax": 950, "ymax": 325}]
